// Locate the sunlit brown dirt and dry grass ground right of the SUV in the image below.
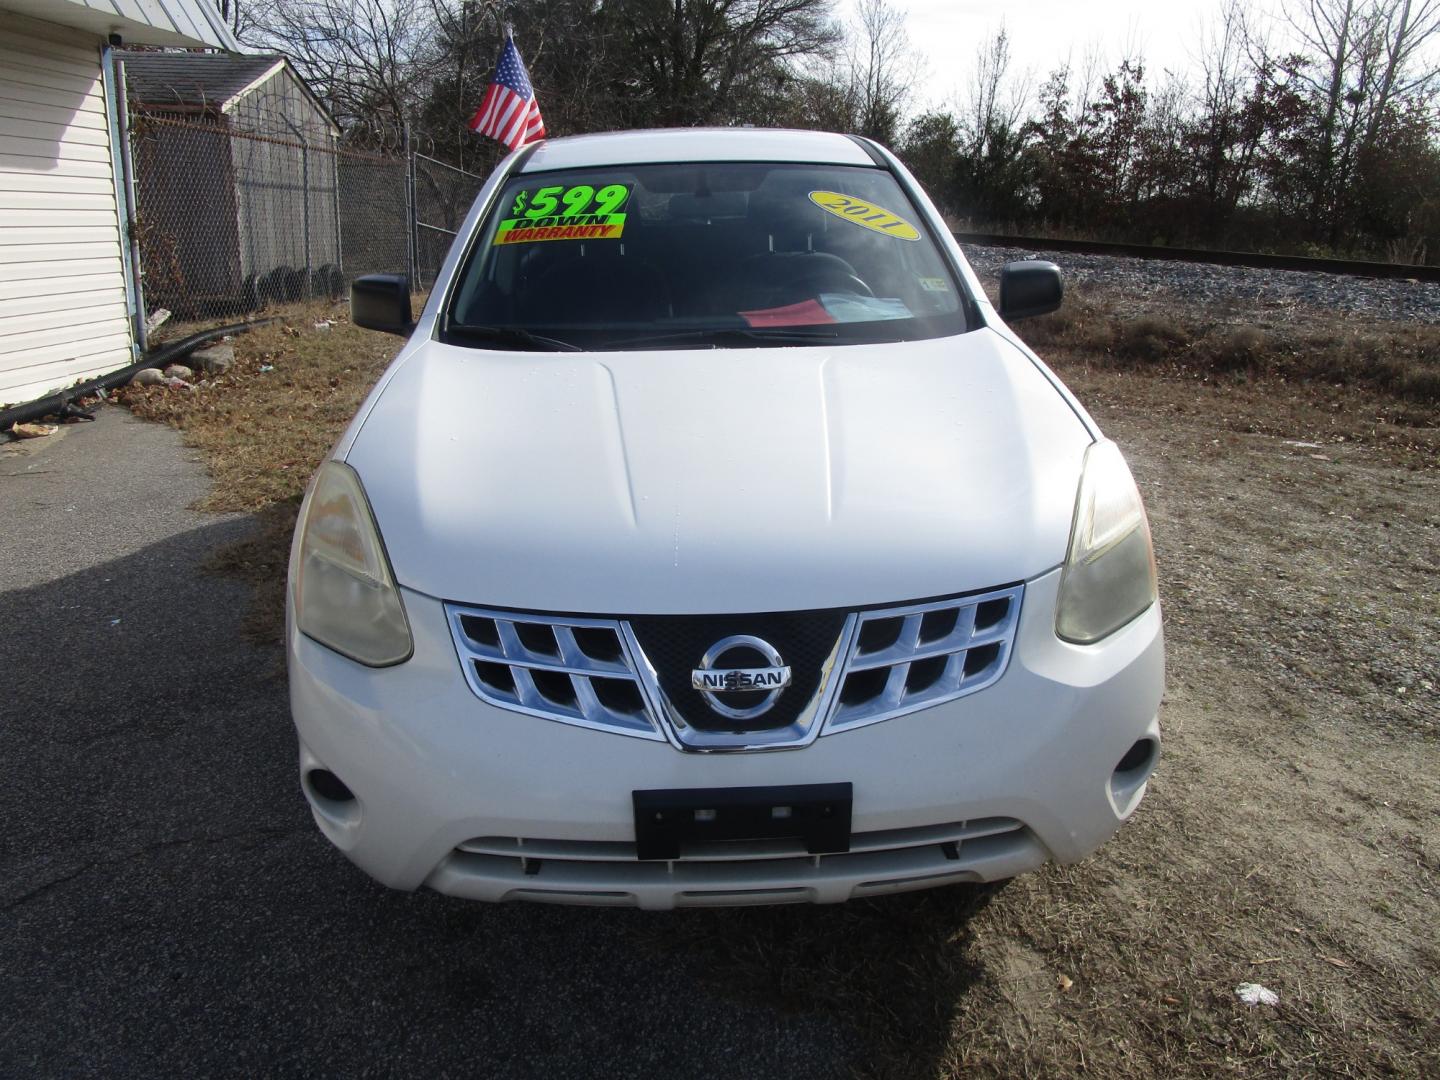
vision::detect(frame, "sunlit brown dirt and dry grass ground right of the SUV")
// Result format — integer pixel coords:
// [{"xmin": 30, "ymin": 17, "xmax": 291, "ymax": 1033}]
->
[{"xmin": 921, "ymin": 360, "xmax": 1440, "ymax": 1076}]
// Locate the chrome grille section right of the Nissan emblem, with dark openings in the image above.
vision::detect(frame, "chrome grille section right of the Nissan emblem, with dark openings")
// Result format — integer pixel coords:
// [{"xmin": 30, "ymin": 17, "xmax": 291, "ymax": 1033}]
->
[{"xmin": 825, "ymin": 585, "xmax": 1024, "ymax": 733}]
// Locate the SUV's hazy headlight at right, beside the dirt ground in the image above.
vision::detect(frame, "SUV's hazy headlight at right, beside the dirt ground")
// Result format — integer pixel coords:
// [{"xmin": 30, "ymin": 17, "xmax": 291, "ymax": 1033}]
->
[{"xmin": 1056, "ymin": 439, "xmax": 1156, "ymax": 645}]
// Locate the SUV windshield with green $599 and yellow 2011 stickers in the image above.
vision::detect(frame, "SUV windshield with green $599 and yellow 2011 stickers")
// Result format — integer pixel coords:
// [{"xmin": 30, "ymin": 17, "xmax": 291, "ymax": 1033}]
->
[{"xmin": 441, "ymin": 163, "xmax": 965, "ymax": 350}]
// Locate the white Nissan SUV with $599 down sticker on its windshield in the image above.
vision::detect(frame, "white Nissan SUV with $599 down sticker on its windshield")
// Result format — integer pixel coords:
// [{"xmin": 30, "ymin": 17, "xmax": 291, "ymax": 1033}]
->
[{"xmin": 288, "ymin": 130, "xmax": 1164, "ymax": 907}]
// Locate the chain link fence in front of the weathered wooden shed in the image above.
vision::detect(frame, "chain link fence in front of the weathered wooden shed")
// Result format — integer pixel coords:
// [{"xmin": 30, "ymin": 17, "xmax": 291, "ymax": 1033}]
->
[{"xmin": 130, "ymin": 112, "xmax": 484, "ymax": 320}]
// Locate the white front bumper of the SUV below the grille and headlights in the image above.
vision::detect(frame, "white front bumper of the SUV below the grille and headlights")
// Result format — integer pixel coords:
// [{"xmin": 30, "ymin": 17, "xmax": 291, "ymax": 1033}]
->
[{"xmin": 289, "ymin": 572, "xmax": 1164, "ymax": 907}]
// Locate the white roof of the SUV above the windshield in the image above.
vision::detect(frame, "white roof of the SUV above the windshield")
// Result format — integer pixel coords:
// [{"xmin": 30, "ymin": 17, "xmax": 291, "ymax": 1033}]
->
[{"xmin": 520, "ymin": 128, "xmax": 874, "ymax": 173}]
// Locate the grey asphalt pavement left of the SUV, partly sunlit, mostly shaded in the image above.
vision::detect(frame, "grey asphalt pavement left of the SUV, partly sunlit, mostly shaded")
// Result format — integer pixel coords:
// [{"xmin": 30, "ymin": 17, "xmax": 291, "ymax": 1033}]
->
[{"xmin": 0, "ymin": 408, "xmax": 863, "ymax": 1077}]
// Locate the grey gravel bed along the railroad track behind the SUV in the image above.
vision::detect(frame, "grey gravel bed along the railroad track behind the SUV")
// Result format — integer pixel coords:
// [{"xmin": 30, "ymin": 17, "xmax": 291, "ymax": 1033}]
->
[{"xmin": 965, "ymin": 245, "xmax": 1440, "ymax": 325}]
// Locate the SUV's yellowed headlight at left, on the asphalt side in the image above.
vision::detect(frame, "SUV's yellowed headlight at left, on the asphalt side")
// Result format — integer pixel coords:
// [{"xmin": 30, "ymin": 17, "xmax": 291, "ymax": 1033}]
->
[{"xmin": 295, "ymin": 461, "xmax": 415, "ymax": 668}]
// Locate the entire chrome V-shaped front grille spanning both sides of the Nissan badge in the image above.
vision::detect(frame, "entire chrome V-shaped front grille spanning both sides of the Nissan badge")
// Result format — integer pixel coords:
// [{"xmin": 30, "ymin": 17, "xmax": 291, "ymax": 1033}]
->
[{"xmin": 445, "ymin": 585, "xmax": 1024, "ymax": 750}]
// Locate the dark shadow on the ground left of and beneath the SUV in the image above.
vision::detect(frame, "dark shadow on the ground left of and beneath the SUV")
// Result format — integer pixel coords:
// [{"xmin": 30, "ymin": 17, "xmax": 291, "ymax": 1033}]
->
[{"xmin": 0, "ymin": 520, "xmax": 996, "ymax": 1077}]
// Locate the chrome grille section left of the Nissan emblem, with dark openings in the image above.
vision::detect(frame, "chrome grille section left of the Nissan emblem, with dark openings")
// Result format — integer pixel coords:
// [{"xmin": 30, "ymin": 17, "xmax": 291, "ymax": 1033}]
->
[{"xmin": 446, "ymin": 605, "xmax": 664, "ymax": 739}]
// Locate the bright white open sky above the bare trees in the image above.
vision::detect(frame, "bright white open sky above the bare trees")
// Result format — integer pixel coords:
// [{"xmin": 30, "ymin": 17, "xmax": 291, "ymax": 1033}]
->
[{"xmin": 890, "ymin": 0, "xmax": 1238, "ymax": 105}]
